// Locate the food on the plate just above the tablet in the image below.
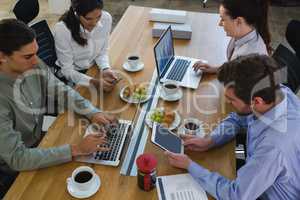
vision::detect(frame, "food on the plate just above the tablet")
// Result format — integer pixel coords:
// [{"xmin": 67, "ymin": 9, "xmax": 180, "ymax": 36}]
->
[{"xmin": 150, "ymin": 108, "xmax": 175, "ymax": 127}]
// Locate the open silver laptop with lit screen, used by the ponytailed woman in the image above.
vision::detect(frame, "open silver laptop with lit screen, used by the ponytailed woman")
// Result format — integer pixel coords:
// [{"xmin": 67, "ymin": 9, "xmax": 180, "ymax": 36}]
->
[{"xmin": 154, "ymin": 26, "xmax": 202, "ymax": 89}]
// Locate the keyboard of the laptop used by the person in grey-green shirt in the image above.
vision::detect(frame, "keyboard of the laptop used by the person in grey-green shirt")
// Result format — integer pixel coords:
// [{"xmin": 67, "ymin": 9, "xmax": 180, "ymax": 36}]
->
[{"xmin": 94, "ymin": 123, "xmax": 130, "ymax": 161}]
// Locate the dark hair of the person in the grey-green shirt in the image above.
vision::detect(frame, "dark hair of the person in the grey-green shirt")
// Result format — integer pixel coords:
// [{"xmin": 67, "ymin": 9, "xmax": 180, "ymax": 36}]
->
[{"xmin": 0, "ymin": 19, "xmax": 36, "ymax": 56}]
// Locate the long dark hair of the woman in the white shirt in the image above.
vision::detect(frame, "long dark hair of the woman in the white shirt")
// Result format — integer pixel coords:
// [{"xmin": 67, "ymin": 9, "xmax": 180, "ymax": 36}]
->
[{"xmin": 59, "ymin": 0, "xmax": 103, "ymax": 46}]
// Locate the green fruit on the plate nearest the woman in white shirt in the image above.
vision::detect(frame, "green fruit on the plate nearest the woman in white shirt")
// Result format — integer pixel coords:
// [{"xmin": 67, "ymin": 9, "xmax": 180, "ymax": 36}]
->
[{"xmin": 123, "ymin": 84, "xmax": 147, "ymax": 100}]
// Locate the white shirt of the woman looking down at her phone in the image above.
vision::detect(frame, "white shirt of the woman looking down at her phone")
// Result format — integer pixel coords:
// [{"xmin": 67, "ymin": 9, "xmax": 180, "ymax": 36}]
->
[{"xmin": 53, "ymin": 11, "xmax": 112, "ymax": 86}]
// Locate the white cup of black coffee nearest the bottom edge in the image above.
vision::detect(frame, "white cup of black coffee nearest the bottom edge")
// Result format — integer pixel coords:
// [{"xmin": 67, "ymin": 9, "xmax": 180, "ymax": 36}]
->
[{"xmin": 67, "ymin": 166, "xmax": 98, "ymax": 191}]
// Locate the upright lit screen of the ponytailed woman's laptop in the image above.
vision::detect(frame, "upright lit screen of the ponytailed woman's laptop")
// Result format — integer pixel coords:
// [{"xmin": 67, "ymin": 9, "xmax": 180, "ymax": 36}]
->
[{"xmin": 154, "ymin": 26, "xmax": 174, "ymax": 77}]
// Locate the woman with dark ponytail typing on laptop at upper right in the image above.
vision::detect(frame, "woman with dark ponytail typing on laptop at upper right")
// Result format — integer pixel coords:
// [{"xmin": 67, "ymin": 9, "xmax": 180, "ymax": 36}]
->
[{"xmin": 194, "ymin": 0, "xmax": 272, "ymax": 73}]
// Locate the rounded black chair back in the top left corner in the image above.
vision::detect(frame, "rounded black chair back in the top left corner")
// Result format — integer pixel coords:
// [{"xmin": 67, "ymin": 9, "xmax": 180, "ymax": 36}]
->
[{"xmin": 13, "ymin": 0, "xmax": 40, "ymax": 24}]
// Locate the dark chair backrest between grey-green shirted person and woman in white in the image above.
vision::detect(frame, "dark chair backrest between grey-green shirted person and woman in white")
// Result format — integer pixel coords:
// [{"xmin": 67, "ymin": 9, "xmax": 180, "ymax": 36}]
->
[{"xmin": 30, "ymin": 20, "xmax": 57, "ymax": 74}]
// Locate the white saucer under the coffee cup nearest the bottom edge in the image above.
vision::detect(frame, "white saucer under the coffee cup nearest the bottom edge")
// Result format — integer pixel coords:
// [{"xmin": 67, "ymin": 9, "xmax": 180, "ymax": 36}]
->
[{"xmin": 67, "ymin": 175, "xmax": 101, "ymax": 199}]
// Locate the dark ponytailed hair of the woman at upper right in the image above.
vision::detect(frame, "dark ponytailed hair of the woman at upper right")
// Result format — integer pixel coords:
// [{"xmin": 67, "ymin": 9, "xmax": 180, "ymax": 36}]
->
[{"xmin": 221, "ymin": 0, "xmax": 272, "ymax": 54}]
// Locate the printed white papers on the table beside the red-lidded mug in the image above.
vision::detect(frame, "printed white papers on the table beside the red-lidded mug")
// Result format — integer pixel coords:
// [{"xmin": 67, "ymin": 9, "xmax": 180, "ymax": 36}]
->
[{"xmin": 156, "ymin": 174, "xmax": 207, "ymax": 200}]
